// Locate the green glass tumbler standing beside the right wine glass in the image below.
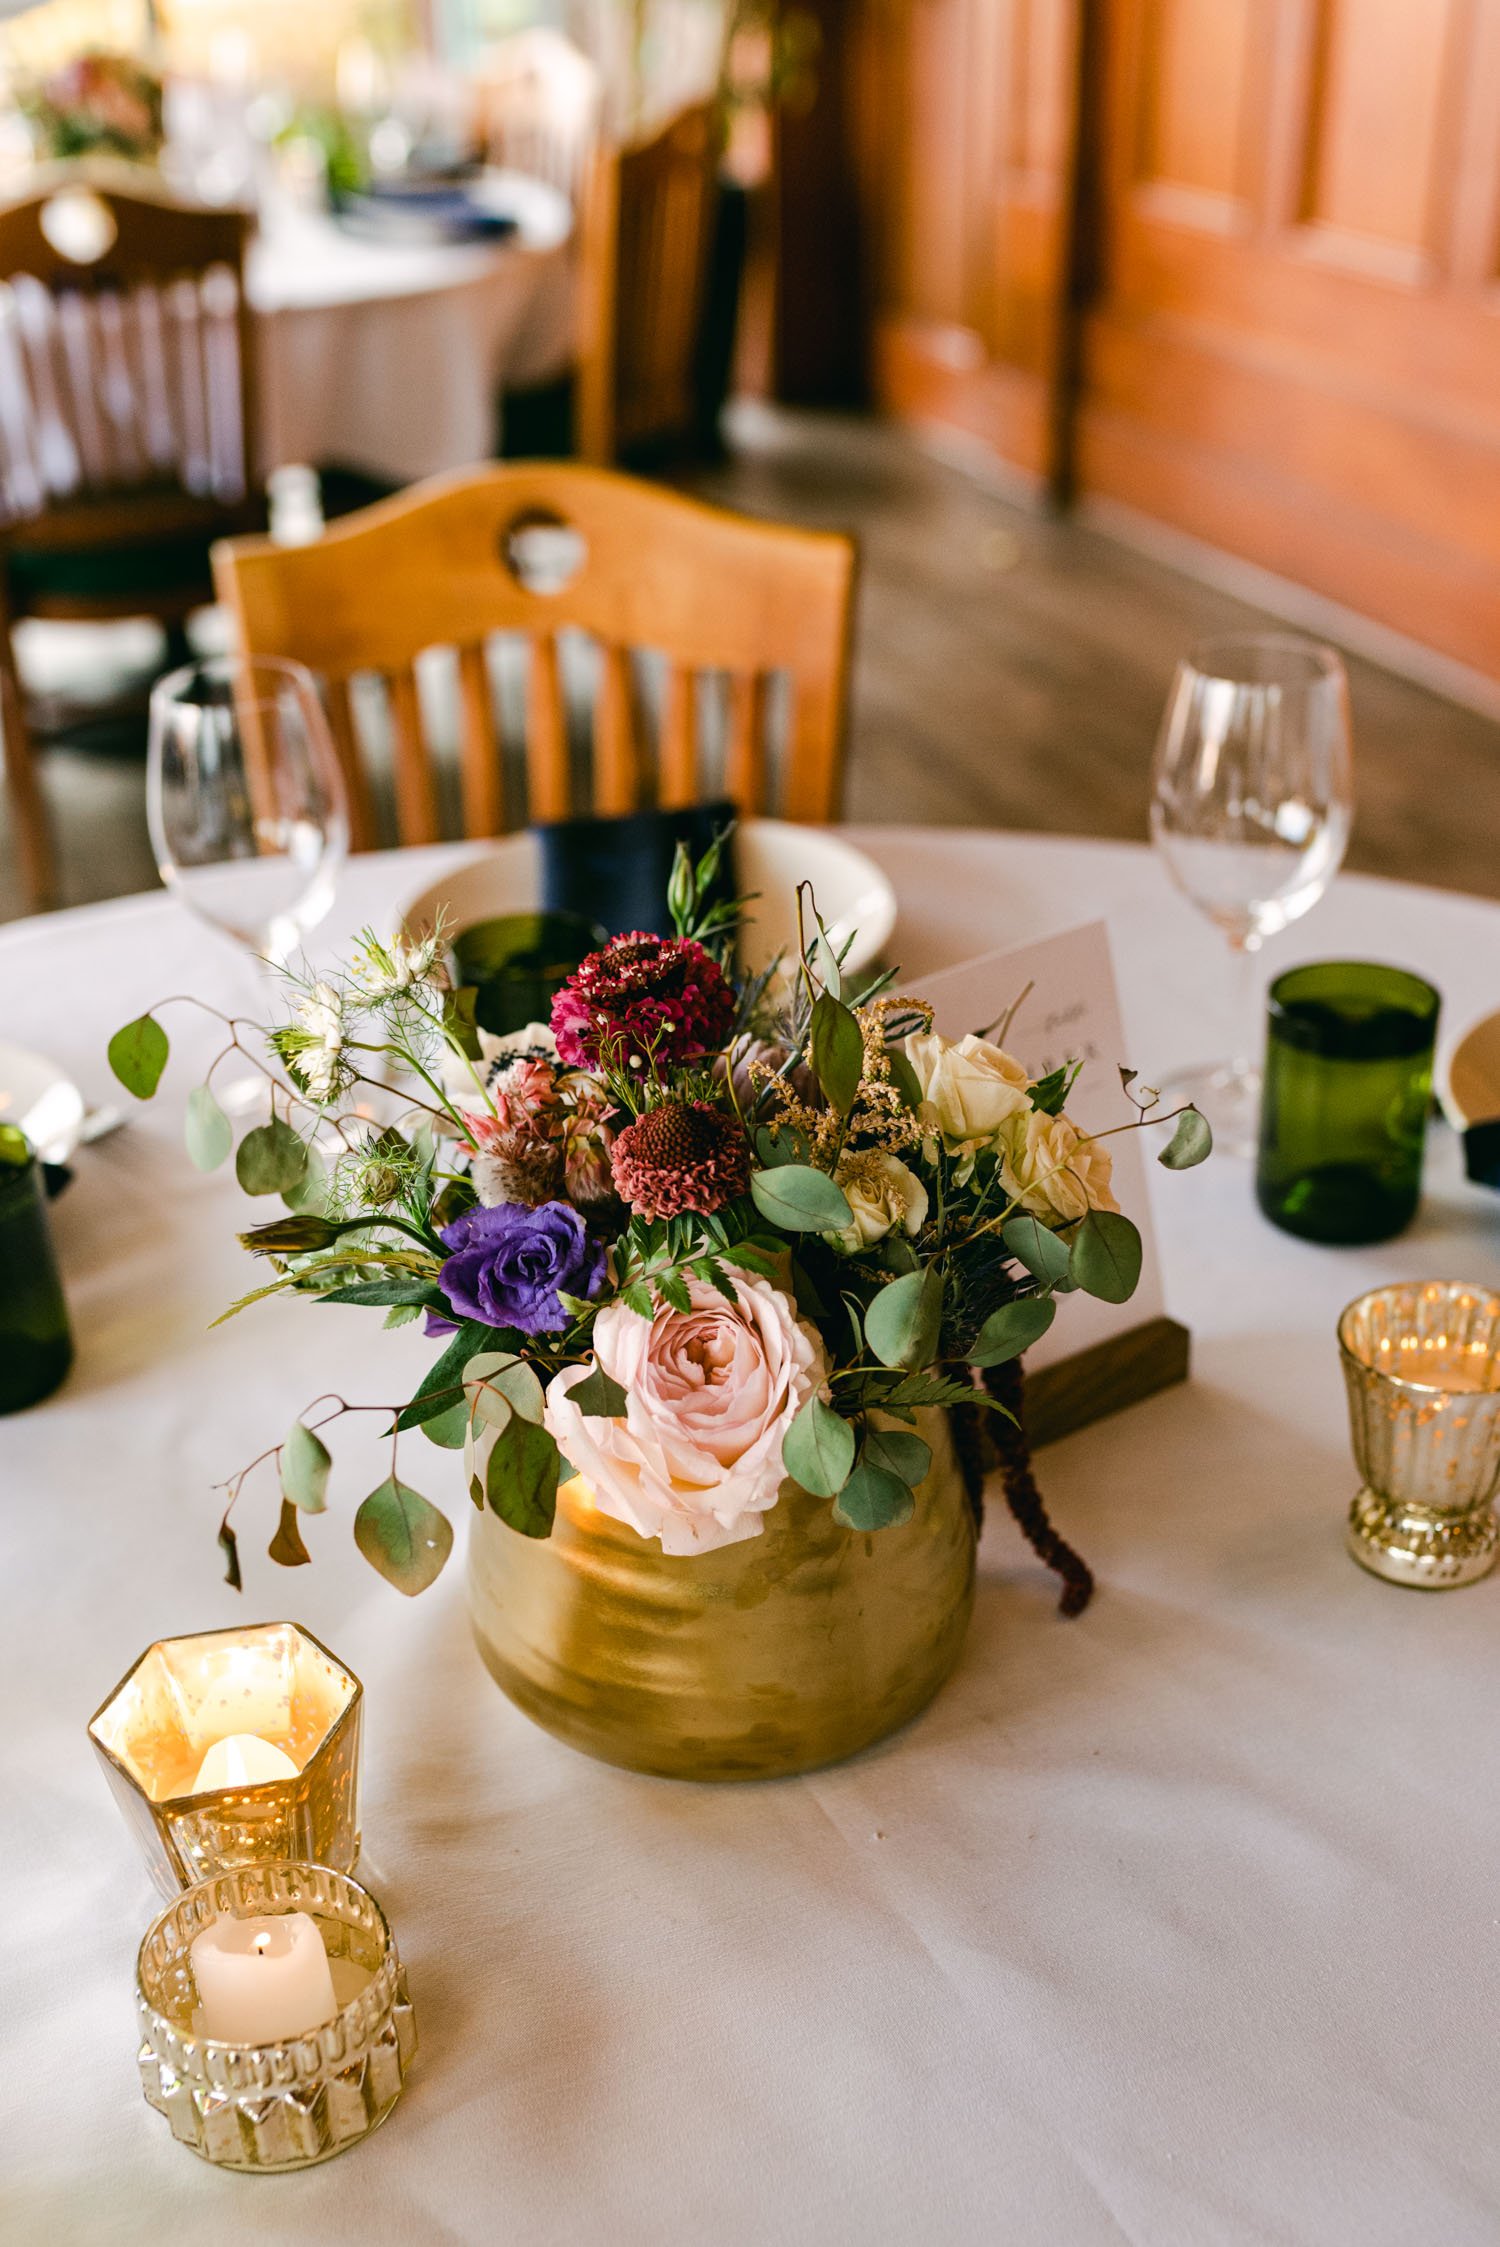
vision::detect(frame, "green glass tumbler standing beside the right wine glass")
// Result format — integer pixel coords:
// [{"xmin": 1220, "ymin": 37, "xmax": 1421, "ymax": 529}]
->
[{"xmin": 1255, "ymin": 959, "xmax": 1439, "ymax": 1247}]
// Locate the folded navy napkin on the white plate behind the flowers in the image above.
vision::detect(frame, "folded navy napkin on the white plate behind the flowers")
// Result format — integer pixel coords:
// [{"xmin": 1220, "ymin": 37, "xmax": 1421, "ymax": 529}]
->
[{"xmin": 534, "ymin": 800, "xmax": 739, "ymax": 937}]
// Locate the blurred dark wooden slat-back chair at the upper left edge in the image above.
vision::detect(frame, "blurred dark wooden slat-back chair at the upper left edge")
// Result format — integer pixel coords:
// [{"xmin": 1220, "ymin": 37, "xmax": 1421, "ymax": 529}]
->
[{"xmin": 0, "ymin": 166, "xmax": 263, "ymax": 906}]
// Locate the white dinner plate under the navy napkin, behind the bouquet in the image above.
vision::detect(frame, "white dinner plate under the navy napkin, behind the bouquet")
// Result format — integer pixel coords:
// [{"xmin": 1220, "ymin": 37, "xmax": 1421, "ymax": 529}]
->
[{"xmin": 392, "ymin": 820, "xmax": 896, "ymax": 973}]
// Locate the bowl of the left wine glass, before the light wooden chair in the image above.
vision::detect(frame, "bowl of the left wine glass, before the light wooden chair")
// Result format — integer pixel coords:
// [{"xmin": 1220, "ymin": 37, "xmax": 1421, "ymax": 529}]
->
[{"xmin": 146, "ymin": 656, "xmax": 348, "ymax": 968}]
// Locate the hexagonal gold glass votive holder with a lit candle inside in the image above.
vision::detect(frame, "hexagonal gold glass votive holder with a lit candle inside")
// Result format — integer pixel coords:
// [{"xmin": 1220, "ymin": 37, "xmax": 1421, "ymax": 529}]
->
[{"xmin": 88, "ymin": 1622, "xmax": 364, "ymax": 1896}]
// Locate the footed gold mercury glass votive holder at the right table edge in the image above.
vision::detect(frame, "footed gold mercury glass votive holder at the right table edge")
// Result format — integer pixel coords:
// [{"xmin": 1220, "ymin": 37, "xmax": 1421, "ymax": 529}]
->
[{"xmin": 1338, "ymin": 1281, "xmax": 1500, "ymax": 1591}]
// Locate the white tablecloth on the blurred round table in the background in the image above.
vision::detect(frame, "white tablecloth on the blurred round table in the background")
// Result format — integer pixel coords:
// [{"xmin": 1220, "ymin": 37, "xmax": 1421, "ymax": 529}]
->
[{"xmin": 245, "ymin": 173, "xmax": 573, "ymax": 483}]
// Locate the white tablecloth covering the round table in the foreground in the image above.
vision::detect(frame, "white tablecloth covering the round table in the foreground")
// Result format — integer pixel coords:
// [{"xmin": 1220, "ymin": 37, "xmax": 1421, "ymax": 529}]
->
[{"xmin": 0, "ymin": 827, "xmax": 1500, "ymax": 2247}]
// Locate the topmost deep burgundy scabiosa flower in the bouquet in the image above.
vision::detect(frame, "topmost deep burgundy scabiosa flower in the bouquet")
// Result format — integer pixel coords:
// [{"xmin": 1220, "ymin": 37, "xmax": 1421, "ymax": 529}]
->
[{"xmin": 552, "ymin": 928, "xmax": 734, "ymax": 1072}]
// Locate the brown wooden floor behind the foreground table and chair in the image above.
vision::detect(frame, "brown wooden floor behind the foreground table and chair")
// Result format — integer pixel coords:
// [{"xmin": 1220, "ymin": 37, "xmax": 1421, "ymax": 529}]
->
[{"xmin": 0, "ymin": 411, "xmax": 1500, "ymax": 919}]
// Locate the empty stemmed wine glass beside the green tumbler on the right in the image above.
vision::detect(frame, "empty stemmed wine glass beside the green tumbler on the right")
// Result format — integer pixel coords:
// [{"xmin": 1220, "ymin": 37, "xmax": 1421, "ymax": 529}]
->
[{"xmin": 1152, "ymin": 631, "xmax": 1354, "ymax": 1155}]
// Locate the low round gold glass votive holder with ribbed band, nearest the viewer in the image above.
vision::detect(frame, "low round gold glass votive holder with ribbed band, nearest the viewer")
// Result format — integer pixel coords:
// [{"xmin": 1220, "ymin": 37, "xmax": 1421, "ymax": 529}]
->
[{"xmin": 135, "ymin": 1865, "xmax": 418, "ymax": 2173}]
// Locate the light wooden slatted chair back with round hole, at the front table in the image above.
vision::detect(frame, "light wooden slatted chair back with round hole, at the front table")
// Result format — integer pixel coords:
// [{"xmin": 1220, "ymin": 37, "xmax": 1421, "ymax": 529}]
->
[{"xmin": 213, "ymin": 463, "xmax": 856, "ymax": 849}]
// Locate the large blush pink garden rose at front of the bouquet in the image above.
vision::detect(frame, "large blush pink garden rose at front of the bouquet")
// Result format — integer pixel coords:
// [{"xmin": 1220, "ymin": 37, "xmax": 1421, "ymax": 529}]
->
[{"xmin": 546, "ymin": 1272, "xmax": 829, "ymax": 1553}]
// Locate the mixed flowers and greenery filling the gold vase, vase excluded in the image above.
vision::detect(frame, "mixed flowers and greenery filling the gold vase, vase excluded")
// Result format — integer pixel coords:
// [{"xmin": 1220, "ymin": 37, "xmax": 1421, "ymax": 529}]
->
[{"xmin": 110, "ymin": 843, "xmax": 1210, "ymax": 1593}]
